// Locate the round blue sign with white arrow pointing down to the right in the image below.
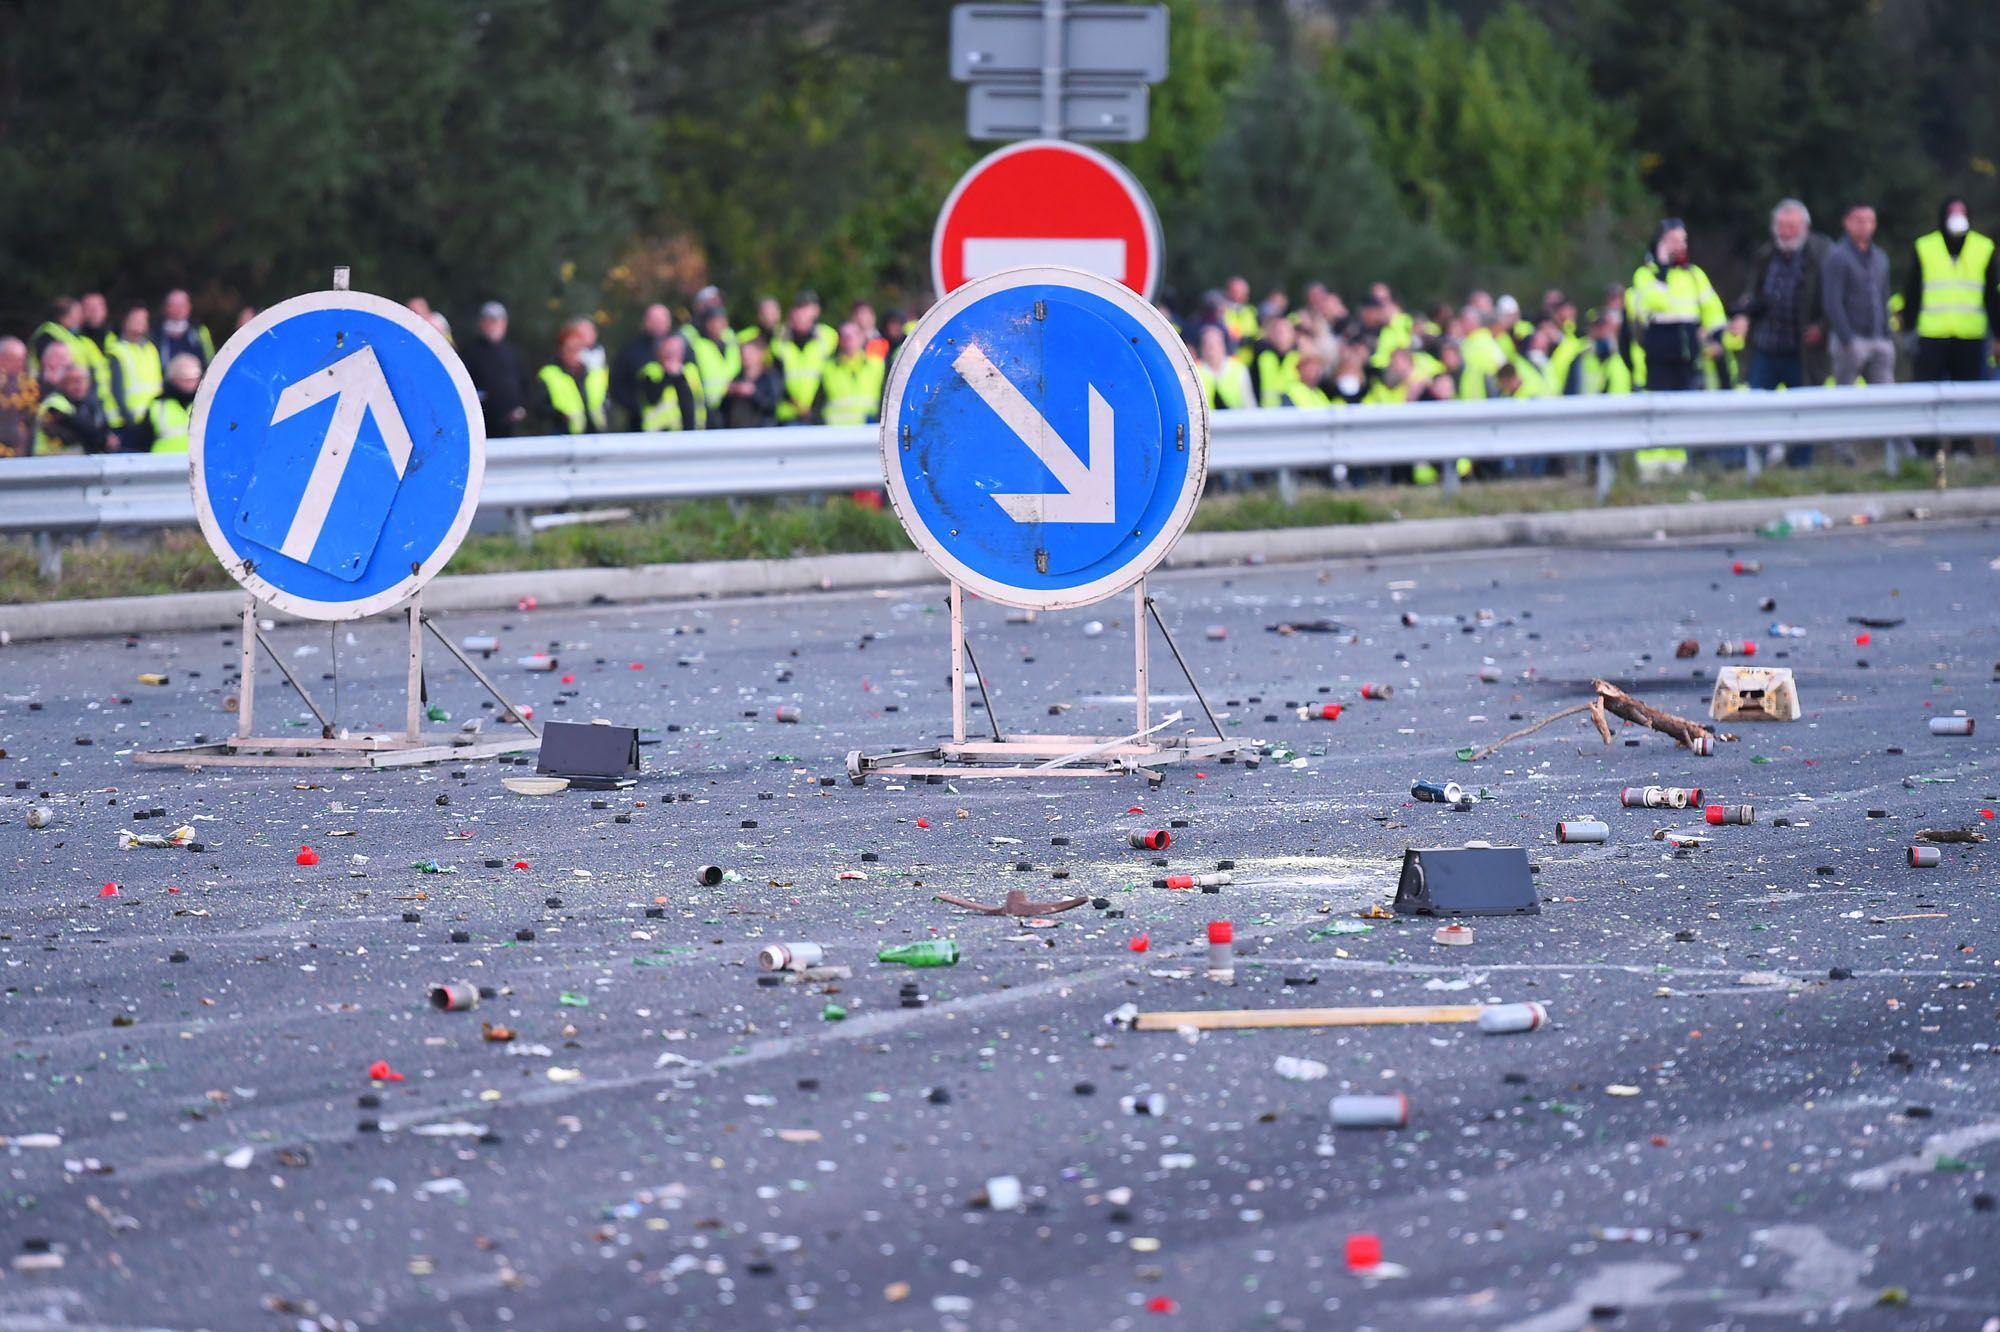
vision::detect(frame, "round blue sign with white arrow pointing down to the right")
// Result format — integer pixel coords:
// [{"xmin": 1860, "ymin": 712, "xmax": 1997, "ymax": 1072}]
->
[{"xmin": 882, "ymin": 268, "xmax": 1208, "ymax": 610}]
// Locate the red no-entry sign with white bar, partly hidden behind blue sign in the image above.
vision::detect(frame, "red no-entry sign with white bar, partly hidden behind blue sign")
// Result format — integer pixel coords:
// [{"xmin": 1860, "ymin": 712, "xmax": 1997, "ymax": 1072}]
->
[{"xmin": 930, "ymin": 138, "xmax": 1160, "ymax": 300}]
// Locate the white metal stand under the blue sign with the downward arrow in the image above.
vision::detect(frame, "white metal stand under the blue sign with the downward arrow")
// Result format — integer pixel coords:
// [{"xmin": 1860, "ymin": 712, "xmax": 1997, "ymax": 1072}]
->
[{"xmin": 848, "ymin": 578, "xmax": 1254, "ymax": 786}]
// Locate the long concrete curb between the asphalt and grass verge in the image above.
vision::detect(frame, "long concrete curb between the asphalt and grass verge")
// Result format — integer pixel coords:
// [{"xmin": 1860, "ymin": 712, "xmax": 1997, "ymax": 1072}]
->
[{"xmin": 0, "ymin": 486, "xmax": 2000, "ymax": 638}]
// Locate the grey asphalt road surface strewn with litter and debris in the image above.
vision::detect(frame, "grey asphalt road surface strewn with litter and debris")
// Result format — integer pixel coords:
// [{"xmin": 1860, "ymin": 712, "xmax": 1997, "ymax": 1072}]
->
[{"xmin": 0, "ymin": 526, "xmax": 2000, "ymax": 1332}]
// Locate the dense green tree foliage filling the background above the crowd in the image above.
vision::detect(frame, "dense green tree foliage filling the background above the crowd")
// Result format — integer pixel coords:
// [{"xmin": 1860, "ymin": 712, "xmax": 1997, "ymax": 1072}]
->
[{"xmin": 0, "ymin": 0, "xmax": 2000, "ymax": 336}]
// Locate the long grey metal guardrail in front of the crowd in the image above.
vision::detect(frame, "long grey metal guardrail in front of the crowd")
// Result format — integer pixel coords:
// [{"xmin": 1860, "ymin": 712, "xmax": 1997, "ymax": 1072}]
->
[{"xmin": 0, "ymin": 382, "xmax": 2000, "ymax": 534}]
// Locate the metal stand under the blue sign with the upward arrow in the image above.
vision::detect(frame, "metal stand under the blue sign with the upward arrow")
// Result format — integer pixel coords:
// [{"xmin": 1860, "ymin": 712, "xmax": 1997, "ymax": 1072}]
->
[{"xmin": 132, "ymin": 590, "xmax": 542, "ymax": 768}]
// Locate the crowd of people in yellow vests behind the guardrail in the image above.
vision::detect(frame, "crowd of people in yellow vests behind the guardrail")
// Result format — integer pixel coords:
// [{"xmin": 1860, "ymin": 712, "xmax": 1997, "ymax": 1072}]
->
[{"xmin": 0, "ymin": 189, "xmax": 2000, "ymax": 482}]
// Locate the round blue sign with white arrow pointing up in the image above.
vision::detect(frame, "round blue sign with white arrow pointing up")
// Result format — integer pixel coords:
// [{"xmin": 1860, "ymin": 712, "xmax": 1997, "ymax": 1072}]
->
[{"xmin": 188, "ymin": 292, "xmax": 486, "ymax": 620}]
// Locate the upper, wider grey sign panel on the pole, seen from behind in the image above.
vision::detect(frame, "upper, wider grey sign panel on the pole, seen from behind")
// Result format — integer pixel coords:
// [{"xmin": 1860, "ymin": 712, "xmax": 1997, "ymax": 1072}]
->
[{"xmin": 952, "ymin": 4, "xmax": 1166, "ymax": 84}]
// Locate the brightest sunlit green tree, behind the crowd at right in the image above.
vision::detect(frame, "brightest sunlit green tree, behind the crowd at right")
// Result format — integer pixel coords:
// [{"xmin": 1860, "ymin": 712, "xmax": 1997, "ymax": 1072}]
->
[{"xmin": 1328, "ymin": 2, "xmax": 1644, "ymax": 282}]
